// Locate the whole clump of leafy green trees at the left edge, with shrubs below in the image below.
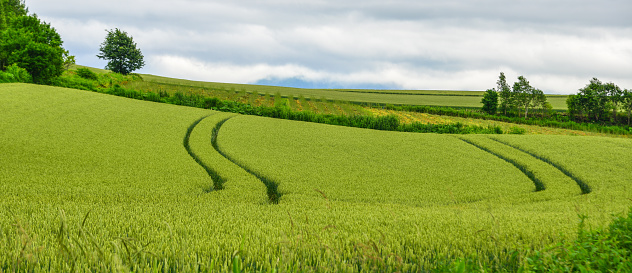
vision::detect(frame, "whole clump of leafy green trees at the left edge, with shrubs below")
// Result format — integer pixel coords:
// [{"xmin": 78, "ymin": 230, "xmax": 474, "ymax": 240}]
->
[{"xmin": 0, "ymin": 0, "xmax": 74, "ymax": 84}]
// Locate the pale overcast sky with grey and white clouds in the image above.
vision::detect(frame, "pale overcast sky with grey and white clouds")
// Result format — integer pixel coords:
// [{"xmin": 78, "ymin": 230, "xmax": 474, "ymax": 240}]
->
[{"xmin": 26, "ymin": 0, "xmax": 632, "ymax": 94}]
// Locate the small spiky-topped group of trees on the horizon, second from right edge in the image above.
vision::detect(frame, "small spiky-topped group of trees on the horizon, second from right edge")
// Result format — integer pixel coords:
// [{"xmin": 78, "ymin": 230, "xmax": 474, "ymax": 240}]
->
[{"xmin": 481, "ymin": 72, "xmax": 551, "ymax": 118}]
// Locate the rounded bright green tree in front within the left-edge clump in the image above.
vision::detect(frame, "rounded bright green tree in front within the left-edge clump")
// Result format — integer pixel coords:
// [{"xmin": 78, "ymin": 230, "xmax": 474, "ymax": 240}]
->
[{"xmin": 0, "ymin": 14, "xmax": 68, "ymax": 84}]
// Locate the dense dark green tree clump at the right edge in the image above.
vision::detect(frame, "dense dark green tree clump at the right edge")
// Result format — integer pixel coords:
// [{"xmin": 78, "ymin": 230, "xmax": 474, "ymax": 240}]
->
[{"xmin": 566, "ymin": 78, "xmax": 632, "ymax": 126}]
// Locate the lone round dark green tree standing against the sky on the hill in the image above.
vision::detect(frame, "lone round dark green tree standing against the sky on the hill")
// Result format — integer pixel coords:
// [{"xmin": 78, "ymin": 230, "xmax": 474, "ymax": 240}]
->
[{"xmin": 97, "ymin": 28, "xmax": 145, "ymax": 75}]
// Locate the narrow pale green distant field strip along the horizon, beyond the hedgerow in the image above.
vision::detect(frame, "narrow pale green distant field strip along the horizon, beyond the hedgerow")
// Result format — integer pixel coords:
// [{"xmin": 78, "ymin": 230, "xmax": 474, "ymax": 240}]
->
[{"xmin": 139, "ymin": 74, "xmax": 567, "ymax": 110}]
